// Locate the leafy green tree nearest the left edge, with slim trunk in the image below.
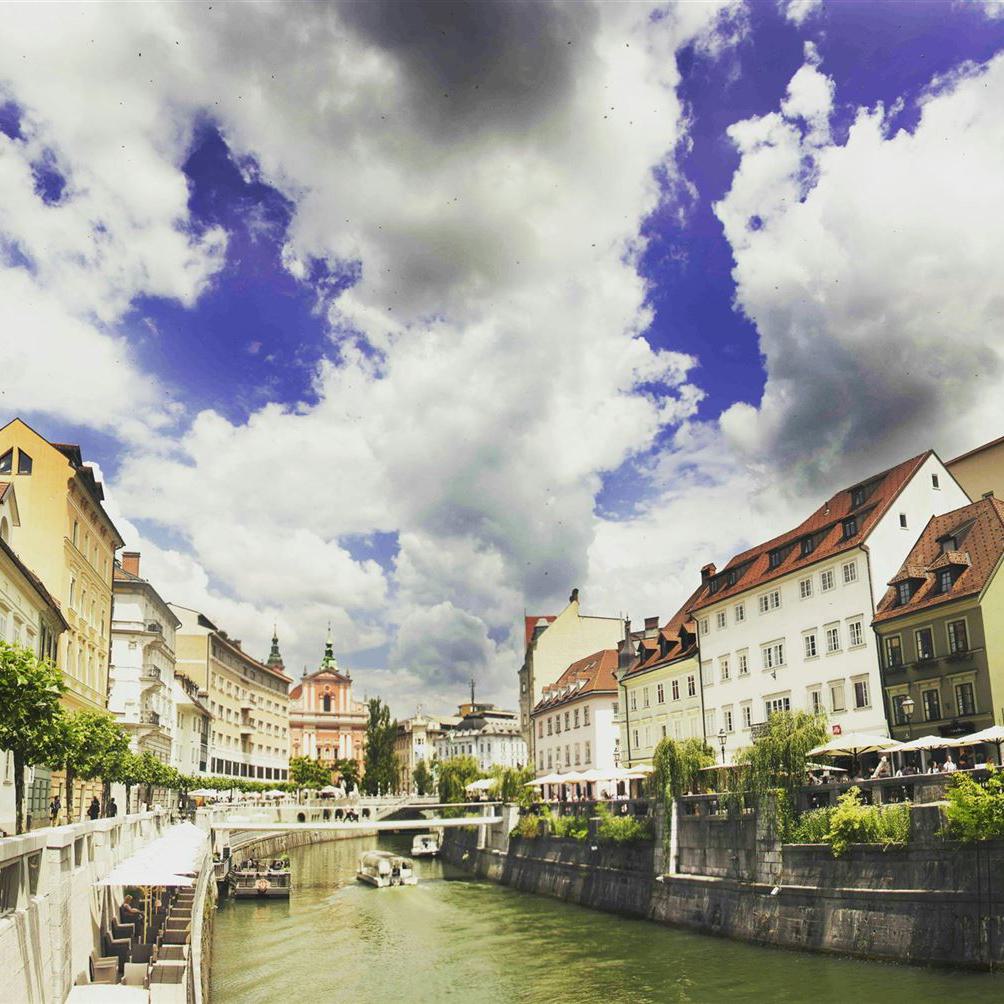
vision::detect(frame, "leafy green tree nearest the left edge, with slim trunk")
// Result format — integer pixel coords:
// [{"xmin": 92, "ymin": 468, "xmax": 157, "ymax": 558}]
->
[{"xmin": 0, "ymin": 642, "xmax": 63, "ymax": 833}]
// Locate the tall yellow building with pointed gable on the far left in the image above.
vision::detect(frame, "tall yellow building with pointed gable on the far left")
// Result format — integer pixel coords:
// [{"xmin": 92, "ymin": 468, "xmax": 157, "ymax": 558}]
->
[{"xmin": 0, "ymin": 419, "xmax": 123, "ymax": 711}]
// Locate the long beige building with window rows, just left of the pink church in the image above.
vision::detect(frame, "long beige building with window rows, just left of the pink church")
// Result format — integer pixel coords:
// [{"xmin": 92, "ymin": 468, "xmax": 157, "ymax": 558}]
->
[{"xmin": 169, "ymin": 603, "xmax": 291, "ymax": 781}]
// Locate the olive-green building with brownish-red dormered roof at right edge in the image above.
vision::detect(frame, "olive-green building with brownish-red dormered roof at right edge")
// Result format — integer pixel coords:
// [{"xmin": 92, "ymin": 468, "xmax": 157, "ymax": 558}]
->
[{"xmin": 872, "ymin": 497, "xmax": 1004, "ymax": 739}]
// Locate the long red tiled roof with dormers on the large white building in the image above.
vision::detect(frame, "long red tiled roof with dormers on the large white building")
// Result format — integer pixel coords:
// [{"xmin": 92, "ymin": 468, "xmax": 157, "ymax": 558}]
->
[{"xmin": 691, "ymin": 450, "xmax": 932, "ymax": 611}]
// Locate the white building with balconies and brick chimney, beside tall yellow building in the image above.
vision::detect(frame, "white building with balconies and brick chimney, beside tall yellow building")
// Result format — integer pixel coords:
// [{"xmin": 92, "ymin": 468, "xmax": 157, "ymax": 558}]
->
[{"xmin": 108, "ymin": 551, "xmax": 181, "ymax": 764}]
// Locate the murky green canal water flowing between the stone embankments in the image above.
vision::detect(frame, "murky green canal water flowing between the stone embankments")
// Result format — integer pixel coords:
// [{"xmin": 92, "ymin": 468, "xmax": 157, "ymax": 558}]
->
[{"xmin": 212, "ymin": 837, "xmax": 1004, "ymax": 1004}]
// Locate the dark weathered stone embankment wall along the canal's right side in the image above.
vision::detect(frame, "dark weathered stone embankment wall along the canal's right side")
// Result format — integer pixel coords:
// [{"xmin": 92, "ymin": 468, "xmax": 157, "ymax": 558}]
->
[{"xmin": 443, "ymin": 805, "xmax": 1004, "ymax": 968}]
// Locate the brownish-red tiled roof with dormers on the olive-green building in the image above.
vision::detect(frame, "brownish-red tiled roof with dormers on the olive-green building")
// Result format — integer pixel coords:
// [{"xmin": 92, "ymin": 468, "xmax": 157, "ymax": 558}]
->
[{"xmin": 871, "ymin": 497, "xmax": 1004, "ymax": 623}]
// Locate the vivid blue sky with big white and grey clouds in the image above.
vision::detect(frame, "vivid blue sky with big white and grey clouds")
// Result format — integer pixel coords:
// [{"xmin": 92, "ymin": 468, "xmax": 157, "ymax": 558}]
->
[{"xmin": 0, "ymin": 0, "xmax": 1004, "ymax": 717}]
